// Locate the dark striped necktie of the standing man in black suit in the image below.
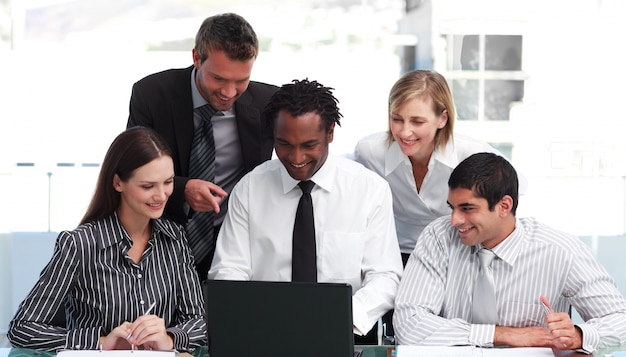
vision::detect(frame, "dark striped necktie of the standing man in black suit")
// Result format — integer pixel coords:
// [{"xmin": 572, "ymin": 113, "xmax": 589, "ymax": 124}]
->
[{"xmin": 187, "ymin": 104, "xmax": 215, "ymax": 268}]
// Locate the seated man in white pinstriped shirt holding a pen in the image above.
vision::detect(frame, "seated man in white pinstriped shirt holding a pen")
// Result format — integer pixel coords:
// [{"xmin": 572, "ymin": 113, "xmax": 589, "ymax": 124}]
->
[{"xmin": 393, "ymin": 153, "xmax": 626, "ymax": 352}]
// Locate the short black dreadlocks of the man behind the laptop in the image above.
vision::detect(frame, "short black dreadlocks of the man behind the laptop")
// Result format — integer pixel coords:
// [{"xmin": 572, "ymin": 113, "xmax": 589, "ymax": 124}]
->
[{"xmin": 263, "ymin": 79, "xmax": 342, "ymax": 132}]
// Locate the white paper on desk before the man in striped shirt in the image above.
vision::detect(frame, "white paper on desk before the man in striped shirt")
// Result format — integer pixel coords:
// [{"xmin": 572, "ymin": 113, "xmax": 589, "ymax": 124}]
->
[{"xmin": 396, "ymin": 345, "xmax": 554, "ymax": 357}]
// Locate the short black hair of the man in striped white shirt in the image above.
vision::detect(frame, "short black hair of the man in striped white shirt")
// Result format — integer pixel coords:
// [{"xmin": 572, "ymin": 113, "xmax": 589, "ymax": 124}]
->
[{"xmin": 448, "ymin": 152, "xmax": 519, "ymax": 215}]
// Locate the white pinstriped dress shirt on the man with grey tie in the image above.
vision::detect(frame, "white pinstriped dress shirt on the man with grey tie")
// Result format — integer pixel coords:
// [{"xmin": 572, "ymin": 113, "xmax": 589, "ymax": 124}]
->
[{"xmin": 393, "ymin": 216, "xmax": 626, "ymax": 352}]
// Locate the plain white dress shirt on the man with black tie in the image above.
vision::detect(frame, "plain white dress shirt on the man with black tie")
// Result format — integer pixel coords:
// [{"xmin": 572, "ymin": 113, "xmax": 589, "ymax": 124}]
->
[{"xmin": 209, "ymin": 155, "xmax": 402, "ymax": 334}]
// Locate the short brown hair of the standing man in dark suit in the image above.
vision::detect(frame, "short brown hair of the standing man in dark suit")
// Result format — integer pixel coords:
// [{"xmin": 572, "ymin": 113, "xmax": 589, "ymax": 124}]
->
[{"xmin": 195, "ymin": 13, "xmax": 259, "ymax": 63}]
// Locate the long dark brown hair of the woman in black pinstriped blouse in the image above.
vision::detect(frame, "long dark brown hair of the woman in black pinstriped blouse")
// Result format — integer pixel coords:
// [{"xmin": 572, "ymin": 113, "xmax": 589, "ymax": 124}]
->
[{"xmin": 80, "ymin": 126, "xmax": 172, "ymax": 224}]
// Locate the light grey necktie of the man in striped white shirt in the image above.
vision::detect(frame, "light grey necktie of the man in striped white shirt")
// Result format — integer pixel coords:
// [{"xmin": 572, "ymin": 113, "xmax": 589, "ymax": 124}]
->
[{"xmin": 472, "ymin": 248, "xmax": 498, "ymax": 324}]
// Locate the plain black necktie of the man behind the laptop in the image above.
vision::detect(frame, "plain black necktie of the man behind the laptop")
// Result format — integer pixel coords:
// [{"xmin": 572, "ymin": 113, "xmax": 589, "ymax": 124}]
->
[{"xmin": 291, "ymin": 181, "xmax": 317, "ymax": 282}]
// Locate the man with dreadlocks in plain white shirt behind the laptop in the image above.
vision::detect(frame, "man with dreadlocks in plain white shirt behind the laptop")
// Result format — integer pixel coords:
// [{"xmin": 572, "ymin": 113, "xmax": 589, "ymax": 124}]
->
[{"xmin": 209, "ymin": 80, "xmax": 402, "ymax": 342}]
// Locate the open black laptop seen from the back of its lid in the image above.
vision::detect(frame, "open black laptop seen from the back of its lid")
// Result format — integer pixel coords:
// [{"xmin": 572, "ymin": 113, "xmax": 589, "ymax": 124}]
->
[{"xmin": 202, "ymin": 280, "xmax": 354, "ymax": 357}]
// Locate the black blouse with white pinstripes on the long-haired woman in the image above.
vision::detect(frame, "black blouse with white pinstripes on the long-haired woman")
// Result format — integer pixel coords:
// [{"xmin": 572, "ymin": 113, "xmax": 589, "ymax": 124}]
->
[{"xmin": 8, "ymin": 213, "xmax": 207, "ymax": 351}]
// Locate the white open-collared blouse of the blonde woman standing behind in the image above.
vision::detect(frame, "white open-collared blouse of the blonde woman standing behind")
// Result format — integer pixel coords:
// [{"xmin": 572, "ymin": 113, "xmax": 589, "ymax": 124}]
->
[{"xmin": 354, "ymin": 132, "xmax": 526, "ymax": 254}]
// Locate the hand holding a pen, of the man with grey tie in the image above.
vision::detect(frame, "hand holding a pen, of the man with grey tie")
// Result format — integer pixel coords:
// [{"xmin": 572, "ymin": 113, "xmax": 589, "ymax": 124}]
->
[{"xmin": 539, "ymin": 295, "xmax": 582, "ymax": 350}]
